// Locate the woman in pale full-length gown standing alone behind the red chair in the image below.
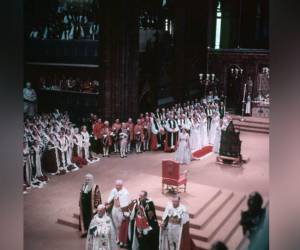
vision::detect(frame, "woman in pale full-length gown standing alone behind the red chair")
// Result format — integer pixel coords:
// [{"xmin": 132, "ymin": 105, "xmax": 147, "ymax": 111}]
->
[{"xmin": 175, "ymin": 128, "xmax": 192, "ymax": 164}]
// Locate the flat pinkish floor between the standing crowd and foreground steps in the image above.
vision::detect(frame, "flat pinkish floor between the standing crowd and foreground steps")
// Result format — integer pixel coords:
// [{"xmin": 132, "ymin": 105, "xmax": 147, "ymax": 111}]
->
[{"xmin": 24, "ymin": 132, "xmax": 269, "ymax": 250}]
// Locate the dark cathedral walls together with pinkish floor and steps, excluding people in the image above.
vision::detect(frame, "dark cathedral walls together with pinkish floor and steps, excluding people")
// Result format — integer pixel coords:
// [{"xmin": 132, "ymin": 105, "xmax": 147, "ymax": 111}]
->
[{"xmin": 24, "ymin": 0, "xmax": 270, "ymax": 250}]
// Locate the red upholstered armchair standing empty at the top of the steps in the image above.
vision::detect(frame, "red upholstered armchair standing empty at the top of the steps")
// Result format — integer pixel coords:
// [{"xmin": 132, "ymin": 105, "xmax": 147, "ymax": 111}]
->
[{"xmin": 162, "ymin": 160, "xmax": 187, "ymax": 193}]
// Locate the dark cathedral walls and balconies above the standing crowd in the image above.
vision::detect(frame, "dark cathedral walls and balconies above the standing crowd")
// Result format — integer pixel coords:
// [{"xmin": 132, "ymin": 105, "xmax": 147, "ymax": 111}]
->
[{"xmin": 24, "ymin": 0, "xmax": 269, "ymax": 119}]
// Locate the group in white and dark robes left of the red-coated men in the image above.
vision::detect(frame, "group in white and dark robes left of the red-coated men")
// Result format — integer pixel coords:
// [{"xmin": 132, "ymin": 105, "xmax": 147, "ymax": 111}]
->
[{"xmin": 23, "ymin": 110, "xmax": 99, "ymax": 188}]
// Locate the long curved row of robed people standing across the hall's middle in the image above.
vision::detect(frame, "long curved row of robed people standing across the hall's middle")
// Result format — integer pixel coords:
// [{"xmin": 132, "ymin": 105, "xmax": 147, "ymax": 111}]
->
[{"xmin": 23, "ymin": 93, "xmax": 231, "ymax": 192}]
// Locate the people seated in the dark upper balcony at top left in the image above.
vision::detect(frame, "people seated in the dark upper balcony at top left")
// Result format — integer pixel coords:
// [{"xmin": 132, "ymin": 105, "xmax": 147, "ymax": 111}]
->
[{"xmin": 28, "ymin": 3, "xmax": 100, "ymax": 40}]
